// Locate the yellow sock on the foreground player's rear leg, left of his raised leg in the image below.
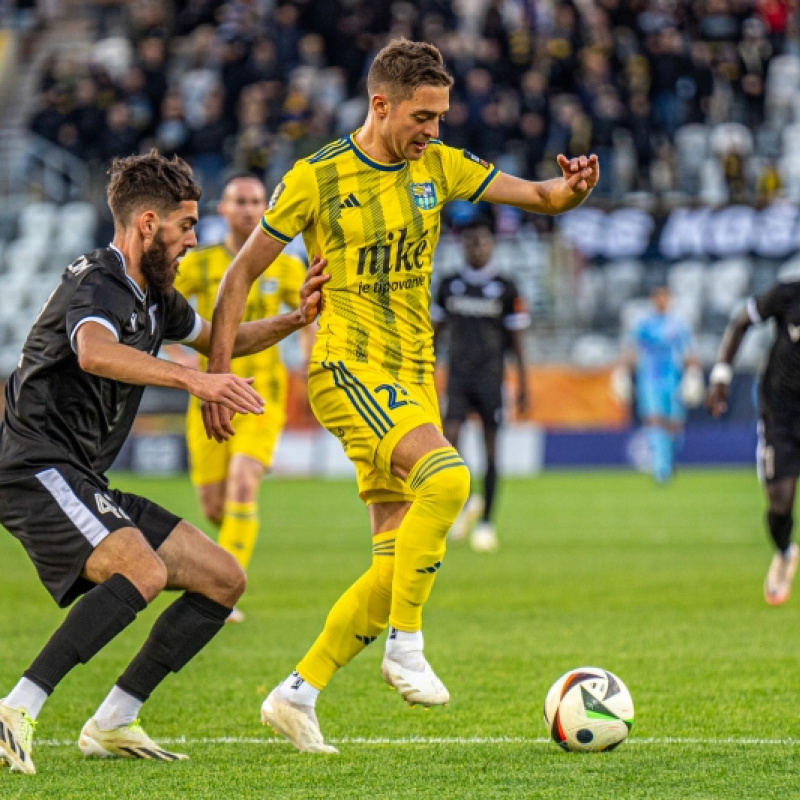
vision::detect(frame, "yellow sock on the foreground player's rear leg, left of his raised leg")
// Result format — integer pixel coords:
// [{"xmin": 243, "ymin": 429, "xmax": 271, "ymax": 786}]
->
[{"xmin": 297, "ymin": 530, "xmax": 397, "ymax": 689}]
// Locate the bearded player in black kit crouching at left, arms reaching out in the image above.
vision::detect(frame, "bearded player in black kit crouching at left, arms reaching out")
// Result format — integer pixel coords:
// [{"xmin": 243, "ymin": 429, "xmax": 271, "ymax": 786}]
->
[{"xmin": 0, "ymin": 151, "xmax": 325, "ymax": 774}]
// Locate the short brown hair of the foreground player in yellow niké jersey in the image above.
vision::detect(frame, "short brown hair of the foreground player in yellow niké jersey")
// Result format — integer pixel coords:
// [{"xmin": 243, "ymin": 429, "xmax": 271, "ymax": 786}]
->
[{"xmin": 367, "ymin": 37, "xmax": 453, "ymax": 101}]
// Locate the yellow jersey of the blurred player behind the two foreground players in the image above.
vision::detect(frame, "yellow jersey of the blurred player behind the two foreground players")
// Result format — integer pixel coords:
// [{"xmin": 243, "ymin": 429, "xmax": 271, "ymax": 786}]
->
[{"xmin": 175, "ymin": 242, "xmax": 306, "ymax": 379}]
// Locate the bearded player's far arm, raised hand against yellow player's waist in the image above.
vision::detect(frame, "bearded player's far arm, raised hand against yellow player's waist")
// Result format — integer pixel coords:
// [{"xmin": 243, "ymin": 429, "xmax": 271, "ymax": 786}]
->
[{"xmin": 188, "ymin": 256, "xmax": 331, "ymax": 358}]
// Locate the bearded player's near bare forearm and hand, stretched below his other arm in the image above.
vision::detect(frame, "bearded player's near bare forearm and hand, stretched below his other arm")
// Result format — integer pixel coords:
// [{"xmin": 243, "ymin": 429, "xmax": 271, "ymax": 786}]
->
[{"xmin": 75, "ymin": 322, "xmax": 264, "ymax": 414}]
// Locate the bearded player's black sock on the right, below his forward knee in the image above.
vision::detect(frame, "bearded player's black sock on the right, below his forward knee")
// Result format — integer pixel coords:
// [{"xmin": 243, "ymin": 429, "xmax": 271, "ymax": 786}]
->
[{"xmin": 117, "ymin": 592, "xmax": 231, "ymax": 702}]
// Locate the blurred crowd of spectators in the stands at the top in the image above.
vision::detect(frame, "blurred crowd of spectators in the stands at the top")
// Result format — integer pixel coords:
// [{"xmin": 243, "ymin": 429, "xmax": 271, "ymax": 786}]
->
[{"xmin": 23, "ymin": 0, "xmax": 800, "ymax": 219}]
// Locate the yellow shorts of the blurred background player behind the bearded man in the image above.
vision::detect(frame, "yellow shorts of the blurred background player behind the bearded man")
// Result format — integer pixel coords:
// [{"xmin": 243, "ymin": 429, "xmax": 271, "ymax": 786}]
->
[{"xmin": 186, "ymin": 397, "xmax": 286, "ymax": 486}]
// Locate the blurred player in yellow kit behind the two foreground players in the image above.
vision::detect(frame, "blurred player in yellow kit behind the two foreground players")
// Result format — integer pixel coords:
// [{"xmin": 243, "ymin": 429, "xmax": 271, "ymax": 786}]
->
[{"xmin": 175, "ymin": 175, "xmax": 306, "ymax": 622}]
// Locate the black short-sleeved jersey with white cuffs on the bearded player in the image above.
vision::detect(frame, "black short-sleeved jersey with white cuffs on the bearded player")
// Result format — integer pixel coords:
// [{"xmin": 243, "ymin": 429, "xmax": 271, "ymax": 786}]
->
[{"xmin": 0, "ymin": 246, "xmax": 201, "ymax": 481}]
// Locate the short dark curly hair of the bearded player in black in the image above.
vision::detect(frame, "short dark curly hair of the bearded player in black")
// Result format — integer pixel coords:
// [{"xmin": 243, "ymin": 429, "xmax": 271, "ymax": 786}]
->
[{"xmin": 106, "ymin": 149, "xmax": 203, "ymax": 226}]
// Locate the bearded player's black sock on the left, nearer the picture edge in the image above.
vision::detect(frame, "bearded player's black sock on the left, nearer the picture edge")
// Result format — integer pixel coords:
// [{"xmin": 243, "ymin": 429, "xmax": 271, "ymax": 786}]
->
[{"xmin": 24, "ymin": 574, "xmax": 147, "ymax": 694}]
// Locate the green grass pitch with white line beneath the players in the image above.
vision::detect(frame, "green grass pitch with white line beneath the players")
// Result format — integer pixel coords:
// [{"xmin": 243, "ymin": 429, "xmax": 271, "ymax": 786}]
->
[{"xmin": 0, "ymin": 470, "xmax": 800, "ymax": 800}]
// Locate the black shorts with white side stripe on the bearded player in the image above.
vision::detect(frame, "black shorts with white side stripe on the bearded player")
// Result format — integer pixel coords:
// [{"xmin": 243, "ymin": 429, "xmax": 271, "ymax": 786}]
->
[{"xmin": 0, "ymin": 464, "xmax": 181, "ymax": 608}]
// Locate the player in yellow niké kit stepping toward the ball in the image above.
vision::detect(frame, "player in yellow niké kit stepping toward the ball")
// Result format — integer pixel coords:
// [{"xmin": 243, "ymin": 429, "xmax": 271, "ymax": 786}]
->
[{"xmin": 203, "ymin": 39, "xmax": 600, "ymax": 753}]
